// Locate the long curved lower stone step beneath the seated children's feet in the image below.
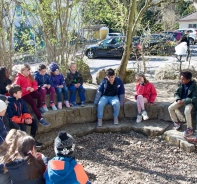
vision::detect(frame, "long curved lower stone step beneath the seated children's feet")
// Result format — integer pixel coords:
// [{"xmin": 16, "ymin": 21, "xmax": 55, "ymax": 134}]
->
[{"xmin": 37, "ymin": 119, "xmax": 169, "ymax": 149}]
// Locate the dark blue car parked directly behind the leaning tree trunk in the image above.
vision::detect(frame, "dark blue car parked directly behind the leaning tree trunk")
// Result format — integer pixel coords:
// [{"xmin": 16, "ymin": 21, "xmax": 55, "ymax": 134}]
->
[{"xmin": 85, "ymin": 36, "xmax": 141, "ymax": 59}]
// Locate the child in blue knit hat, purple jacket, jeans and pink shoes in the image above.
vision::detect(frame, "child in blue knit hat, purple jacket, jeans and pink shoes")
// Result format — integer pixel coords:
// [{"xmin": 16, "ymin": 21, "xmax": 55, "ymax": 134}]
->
[{"xmin": 49, "ymin": 62, "xmax": 70, "ymax": 109}]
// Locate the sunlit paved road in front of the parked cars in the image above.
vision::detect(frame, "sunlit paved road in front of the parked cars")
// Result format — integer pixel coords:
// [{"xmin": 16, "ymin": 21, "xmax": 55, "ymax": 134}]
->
[{"xmin": 86, "ymin": 45, "xmax": 197, "ymax": 83}]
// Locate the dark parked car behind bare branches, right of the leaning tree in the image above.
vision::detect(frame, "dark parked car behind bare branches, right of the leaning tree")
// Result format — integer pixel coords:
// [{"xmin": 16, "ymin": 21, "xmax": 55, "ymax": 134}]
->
[{"xmin": 140, "ymin": 34, "xmax": 177, "ymax": 55}]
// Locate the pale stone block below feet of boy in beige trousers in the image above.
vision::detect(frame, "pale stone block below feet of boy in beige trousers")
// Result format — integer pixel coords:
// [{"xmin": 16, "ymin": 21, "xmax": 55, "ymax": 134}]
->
[{"xmin": 164, "ymin": 130, "xmax": 195, "ymax": 152}]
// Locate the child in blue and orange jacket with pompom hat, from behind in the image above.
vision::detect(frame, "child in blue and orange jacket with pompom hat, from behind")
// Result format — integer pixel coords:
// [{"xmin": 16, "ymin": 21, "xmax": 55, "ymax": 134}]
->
[{"xmin": 44, "ymin": 131, "xmax": 91, "ymax": 184}]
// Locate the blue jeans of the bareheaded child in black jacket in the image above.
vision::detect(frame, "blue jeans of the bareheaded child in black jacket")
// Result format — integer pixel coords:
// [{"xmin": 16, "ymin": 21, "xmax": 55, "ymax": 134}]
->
[{"xmin": 68, "ymin": 85, "xmax": 86, "ymax": 103}]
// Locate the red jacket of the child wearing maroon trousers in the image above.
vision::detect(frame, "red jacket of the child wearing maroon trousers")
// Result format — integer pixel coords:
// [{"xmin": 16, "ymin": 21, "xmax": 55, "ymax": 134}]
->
[{"xmin": 14, "ymin": 73, "xmax": 38, "ymax": 96}]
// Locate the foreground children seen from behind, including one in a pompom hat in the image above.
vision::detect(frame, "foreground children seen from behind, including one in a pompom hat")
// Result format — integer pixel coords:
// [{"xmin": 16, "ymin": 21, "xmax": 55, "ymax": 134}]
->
[{"xmin": 0, "ymin": 129, "xmax": 91, "ymax": 184}]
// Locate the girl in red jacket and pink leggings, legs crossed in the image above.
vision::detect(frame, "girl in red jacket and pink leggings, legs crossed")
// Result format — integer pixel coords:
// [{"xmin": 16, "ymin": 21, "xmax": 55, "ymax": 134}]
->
[{"xmin": 135, "ymin": 73, "xmax": 157, "ymax": 123}]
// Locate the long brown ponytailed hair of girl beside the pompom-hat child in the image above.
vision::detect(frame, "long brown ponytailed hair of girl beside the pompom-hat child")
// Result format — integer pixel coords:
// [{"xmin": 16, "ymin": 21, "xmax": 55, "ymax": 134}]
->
[{"xmin": 18, "ymin": 136, "xmax": 46, "ymax": 179}]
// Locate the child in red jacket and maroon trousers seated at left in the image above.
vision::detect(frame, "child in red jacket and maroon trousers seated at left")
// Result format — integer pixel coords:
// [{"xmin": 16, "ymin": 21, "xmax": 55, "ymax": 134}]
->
[{"xmin": 14, "ymin": 64, "xmax": 50, "ymax": 126}]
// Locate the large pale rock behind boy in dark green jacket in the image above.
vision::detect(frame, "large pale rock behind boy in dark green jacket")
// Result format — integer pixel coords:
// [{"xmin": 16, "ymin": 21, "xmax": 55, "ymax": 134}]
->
[{"xmin": 155, "ymin": 62, "xmax": 197, "ymax": 80}]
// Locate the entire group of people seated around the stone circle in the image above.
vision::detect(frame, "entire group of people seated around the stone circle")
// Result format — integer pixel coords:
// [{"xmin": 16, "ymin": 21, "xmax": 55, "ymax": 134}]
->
[{"xmin": 0, "ymin": 62, "xmax": 197, "ymax": 184}]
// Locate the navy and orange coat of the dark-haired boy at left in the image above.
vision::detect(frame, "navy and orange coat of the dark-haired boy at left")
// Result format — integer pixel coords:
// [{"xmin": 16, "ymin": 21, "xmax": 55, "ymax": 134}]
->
[{"xmin": 7, "ymin": 97, "xmax": 32, "ymax": 124}]
